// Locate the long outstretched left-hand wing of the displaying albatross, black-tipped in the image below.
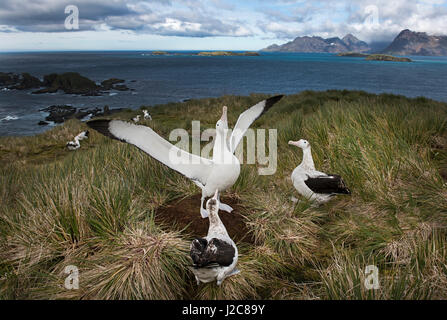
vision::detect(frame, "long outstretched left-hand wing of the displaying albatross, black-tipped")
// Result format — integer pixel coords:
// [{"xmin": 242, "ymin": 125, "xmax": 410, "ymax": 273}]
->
[{"xmin": 87, "ymin": 120, "xmax": 213, "ymax": 185}]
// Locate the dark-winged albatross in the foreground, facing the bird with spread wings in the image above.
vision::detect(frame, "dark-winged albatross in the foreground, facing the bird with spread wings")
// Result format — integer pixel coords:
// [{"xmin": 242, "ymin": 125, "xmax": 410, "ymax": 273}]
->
[{"xmin": 190, "ymin": 190, "xmax": 240, "ymax": 286}]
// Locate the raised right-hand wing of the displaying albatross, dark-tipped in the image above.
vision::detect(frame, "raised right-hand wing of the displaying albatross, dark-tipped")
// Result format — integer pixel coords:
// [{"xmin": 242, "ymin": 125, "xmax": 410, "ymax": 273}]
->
[{"xmin": 230, "ymin": 95, "xmax": 283, "ymax": 152}]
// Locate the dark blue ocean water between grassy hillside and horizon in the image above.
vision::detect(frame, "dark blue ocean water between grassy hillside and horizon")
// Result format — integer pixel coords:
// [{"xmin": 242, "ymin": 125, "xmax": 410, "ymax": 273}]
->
[{"xmin": 0, "ymin": 51, "xmax": 447, "ymax": 136}]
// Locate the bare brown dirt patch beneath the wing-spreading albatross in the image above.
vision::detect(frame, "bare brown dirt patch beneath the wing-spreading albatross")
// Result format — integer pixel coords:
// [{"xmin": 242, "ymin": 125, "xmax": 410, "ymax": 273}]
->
[{"xmin": 155, "ymin": 195, "xmax": 254, "ymax": 243}]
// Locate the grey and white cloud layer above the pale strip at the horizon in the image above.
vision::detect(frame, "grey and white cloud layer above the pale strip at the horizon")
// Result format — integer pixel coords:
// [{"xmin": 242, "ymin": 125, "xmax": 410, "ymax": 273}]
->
[{"xmin": 0, "ymin": 0, "xmax": 447, "ymax": 49}]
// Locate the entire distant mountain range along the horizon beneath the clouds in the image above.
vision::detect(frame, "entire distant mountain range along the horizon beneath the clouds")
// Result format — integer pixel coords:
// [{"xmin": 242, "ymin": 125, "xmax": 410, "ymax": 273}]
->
[{"xmin": 261, "ymin": 29, "xmax": 447, "ymax": 56}]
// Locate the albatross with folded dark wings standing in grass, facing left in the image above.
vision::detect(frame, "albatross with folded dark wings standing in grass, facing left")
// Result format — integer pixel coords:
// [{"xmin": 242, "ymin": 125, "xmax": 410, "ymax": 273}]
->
[{"xmin": 289, "ymin": 139, "xmax": 351, "ymax": 204}]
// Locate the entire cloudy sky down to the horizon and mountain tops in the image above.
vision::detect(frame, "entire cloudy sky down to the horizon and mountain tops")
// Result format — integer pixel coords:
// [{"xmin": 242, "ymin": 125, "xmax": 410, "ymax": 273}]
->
[{"xmin": 0, "ymin": 0, "xmax": 447, "ymax": 51}]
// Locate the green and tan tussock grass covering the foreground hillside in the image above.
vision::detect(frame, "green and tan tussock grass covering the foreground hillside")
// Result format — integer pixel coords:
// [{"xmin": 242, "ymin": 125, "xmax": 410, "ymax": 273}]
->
[{"xmin": 0, "ymin": 91, "xmax": 447, "ymax": 299}]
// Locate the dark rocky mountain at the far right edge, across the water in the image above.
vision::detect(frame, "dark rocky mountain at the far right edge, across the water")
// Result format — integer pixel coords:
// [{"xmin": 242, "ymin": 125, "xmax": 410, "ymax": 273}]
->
[{"xmin": 382, "ymin": 29, "xmax": 447, "ymax": 56}]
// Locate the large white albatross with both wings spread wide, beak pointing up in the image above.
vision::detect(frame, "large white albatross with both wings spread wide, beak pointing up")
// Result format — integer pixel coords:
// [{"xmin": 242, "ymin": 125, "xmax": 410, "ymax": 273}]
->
[{"xmin": 87, "ymin": 95, "xmax": 283, "ymax": 218}]
